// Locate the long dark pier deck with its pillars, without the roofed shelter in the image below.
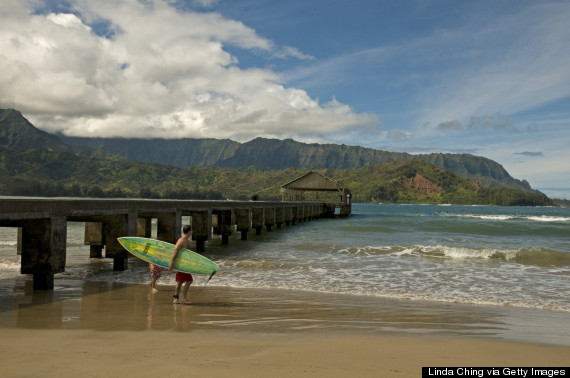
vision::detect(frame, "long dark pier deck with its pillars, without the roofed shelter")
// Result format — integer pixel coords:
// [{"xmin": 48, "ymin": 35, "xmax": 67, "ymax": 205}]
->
[{"xmin": 0, "ymin": 198, "xmax": 350, "ymax": 290}]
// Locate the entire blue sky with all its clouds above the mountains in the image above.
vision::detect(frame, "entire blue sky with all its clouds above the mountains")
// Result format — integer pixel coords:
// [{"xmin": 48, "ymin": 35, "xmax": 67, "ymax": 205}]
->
[{"xmin": 0, "ymin": 0, "xmax": 570, "ymax": 197}]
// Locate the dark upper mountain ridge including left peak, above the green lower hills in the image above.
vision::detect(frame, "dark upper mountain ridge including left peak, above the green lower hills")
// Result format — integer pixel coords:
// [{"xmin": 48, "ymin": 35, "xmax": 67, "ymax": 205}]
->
[{"xmin": 0, "ymin": 109, "xmax": 532, "ymax": 191}]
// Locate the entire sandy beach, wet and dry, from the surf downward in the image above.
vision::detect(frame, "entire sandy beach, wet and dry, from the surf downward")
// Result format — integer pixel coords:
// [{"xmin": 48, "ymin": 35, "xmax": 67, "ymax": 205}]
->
[{"xmin": 0, "ymin": 279, "xmax": 570, "ymax": 377}]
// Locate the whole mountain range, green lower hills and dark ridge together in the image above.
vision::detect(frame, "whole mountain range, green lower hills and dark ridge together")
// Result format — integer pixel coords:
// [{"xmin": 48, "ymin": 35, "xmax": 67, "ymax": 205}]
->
[{"xmin": 0, "ymin": 110, "xmax": 551, "ymax": 205}]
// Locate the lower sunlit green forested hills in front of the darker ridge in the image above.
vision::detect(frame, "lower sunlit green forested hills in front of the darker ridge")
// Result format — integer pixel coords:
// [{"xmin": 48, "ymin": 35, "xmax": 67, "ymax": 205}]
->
[{"xmin": 0, "ymin": 147, "xmax": 552, "ymax": 206}]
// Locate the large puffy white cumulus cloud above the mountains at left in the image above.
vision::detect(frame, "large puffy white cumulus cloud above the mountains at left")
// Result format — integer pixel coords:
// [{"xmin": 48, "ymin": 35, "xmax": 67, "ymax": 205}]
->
[{"xmin": 0, "ymin": 0, "xmax": 379, "ymax": 140}]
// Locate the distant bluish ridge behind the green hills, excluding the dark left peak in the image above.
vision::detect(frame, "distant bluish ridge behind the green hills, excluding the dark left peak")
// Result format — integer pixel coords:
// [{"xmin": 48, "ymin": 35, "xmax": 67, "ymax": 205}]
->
[{"xmin": 58, "ymin": 137, "xmax": 531, "ymax": 190}]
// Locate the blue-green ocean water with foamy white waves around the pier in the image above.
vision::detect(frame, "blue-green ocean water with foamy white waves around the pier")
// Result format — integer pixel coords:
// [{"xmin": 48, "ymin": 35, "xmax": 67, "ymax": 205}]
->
[{"xmin": 0, "ymin": 204, "xmax": 570, "ymax": 312}]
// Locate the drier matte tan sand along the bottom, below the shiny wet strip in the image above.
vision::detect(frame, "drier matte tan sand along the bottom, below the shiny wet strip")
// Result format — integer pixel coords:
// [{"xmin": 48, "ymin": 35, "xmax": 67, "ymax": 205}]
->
[{"xmin": 2, "ymin": 329, "xmax": 570, "ymax": 377}]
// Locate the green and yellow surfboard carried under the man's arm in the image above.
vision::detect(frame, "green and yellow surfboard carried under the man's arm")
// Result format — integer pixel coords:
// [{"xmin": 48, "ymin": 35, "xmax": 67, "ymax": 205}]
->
[{"xmin": 117, "ymin": 236, "xmax": 220, "ymax": 275}]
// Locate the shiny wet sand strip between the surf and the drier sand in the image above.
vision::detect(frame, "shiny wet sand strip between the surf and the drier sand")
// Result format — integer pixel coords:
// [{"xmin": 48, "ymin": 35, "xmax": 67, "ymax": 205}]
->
[{"xmin": 0, "ymin": 280, "xmax": 570, "ymax": 344}]
